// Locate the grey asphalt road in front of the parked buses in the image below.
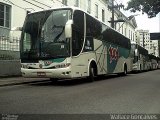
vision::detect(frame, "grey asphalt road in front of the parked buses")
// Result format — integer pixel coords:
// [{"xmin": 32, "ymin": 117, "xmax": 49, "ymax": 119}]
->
[{"xmin": 0, "ymin": 70, "xmax": 160, "ymax": 114}]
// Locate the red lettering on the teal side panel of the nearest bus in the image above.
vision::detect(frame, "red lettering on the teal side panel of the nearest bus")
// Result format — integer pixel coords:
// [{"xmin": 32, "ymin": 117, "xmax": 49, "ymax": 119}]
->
[{"xmin": 109, "ymin": 45, "xmax": 119, "ymax": 63}]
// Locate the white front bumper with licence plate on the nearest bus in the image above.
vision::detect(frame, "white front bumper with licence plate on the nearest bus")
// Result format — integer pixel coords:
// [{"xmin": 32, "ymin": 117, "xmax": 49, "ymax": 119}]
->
[{"xmin": 21, "ymin": 67, "xmax": 72, "ymax": 78}]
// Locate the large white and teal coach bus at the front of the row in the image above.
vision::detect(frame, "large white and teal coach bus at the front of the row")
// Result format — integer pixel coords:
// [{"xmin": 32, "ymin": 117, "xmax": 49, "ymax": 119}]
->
[{"xmin": 20, "ymin": 7, "xmax": 132, "ymax": 81}]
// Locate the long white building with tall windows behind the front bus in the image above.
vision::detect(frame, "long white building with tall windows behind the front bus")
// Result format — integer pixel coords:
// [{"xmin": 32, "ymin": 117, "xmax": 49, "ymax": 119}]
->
[{"xmin": 0, "ymin": 0, "xmax": 137, "ymax": 51}]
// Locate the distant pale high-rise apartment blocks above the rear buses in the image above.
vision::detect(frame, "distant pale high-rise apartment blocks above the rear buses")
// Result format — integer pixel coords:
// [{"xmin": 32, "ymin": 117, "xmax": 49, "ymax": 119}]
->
[{"xmin": 136, "ymin": 30, "xmax": 159, "ymax": 56}]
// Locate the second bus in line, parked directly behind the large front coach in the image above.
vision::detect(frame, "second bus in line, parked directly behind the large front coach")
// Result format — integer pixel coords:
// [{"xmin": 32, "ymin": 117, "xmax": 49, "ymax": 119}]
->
[{"xmin": 131, "ymin": 43, "xmax": 151, "ymax": 72}]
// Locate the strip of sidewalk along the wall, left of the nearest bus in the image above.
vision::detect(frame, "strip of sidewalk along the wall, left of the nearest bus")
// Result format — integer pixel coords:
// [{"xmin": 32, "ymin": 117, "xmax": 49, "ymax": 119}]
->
[{"xmin": 0, "ymin": 76, "xmax": 49, "ymax": 87}]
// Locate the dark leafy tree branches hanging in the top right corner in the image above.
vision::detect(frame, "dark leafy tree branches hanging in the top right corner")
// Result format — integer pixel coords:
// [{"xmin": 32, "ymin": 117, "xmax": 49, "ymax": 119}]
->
[{"xmin": 126, "ymin": 0, "xmax": 160, "ymax": 18}]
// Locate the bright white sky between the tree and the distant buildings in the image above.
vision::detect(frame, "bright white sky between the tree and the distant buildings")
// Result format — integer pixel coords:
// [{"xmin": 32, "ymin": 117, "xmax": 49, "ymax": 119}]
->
[{"xmin": 115, "ymin": 0, "xmax": 160, "ymax": 33}]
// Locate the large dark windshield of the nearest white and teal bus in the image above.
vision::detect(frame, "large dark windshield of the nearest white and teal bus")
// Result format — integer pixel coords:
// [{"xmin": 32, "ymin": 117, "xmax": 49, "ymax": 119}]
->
[{"xmin": 21, "ymin": 9, "xmax": 71, "ymax": 60}]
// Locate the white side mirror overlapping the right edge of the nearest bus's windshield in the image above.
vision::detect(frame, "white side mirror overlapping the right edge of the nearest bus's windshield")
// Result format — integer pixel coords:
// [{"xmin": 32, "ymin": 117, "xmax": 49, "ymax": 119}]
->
[{"xmin": 65, "ymin": 20, "xmax": 73, "ymax": 38}]
